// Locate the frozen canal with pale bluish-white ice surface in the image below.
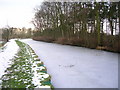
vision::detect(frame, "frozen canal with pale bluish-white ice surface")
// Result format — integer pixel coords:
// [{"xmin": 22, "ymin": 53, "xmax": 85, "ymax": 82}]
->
[{"xmin": 22, "ymin": 39, "xmax": 118, "ymax": 88}]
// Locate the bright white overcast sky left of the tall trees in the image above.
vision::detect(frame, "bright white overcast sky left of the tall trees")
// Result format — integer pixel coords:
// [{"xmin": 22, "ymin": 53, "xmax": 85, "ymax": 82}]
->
[{"xmin": 0, "ymin": 0, "xmax": 43, "ymax": 28}]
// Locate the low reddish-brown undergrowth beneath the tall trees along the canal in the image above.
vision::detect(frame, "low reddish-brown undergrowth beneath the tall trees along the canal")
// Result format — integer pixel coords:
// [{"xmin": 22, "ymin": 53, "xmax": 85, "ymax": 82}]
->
[{"xmin": 33, "ymin": 36, "xmax": 120, "ymax": 52}]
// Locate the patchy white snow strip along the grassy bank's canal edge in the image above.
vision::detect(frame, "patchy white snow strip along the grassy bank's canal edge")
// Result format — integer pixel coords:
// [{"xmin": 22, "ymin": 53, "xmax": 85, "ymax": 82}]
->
[{"xmin": 25, "ymin": 44, "xmax": 51, "ymax": 90}]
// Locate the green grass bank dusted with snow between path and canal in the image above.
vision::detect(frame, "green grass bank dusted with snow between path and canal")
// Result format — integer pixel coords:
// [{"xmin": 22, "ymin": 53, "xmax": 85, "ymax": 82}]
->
[{"xmin": 1, "ymin": 40, "xmax": 52, "ymax": 88}]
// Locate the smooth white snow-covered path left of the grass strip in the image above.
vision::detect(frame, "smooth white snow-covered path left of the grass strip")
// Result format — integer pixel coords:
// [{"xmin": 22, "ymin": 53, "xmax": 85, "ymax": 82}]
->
[{"xmin": 0, "ymin": 39, "xmax": 19, "ymax": 80}]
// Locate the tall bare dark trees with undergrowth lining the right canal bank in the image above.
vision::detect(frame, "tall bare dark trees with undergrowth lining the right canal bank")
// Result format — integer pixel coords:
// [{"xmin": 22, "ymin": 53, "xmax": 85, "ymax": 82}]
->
[{"xmin": 32, "ymin": 2, "xmax": 120, "ymax": 52}]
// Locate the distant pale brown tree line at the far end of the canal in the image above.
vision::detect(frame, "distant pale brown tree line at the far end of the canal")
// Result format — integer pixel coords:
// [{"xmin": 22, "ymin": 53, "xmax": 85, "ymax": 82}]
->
[{"xmin": 1, "ymin": 26, "xmax": 33, "ymax": 42}]
